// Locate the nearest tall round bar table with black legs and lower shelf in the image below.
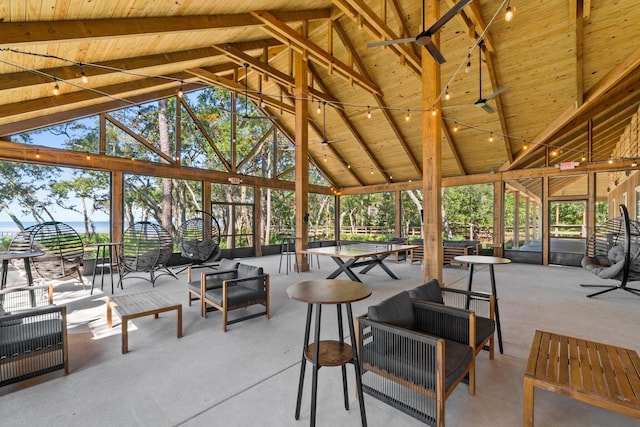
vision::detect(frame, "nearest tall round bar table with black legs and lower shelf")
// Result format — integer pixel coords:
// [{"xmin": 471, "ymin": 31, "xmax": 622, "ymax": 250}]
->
[{"xmin": 287, "ymin": 279, "xmax": 371, "ymax": 427}]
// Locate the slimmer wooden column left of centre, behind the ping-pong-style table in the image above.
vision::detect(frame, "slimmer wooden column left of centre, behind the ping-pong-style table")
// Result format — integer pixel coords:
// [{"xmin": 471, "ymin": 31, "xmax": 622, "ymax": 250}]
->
[{"xmin": 293, "ymin": 52, "xmax": 309, "ymax": 271}]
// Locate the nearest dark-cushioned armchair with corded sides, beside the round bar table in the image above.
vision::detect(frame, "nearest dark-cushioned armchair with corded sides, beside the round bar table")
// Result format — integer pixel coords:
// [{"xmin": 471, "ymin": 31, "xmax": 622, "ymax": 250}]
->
[{"xmin": 357, "ymin": 291, "xmax": 475, "ymax": 426}]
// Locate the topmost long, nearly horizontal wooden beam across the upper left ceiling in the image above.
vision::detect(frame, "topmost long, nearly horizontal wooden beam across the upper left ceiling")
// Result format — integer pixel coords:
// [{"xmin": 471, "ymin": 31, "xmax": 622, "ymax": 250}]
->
[{"xmin": 0, "ymin": 9, "xmax": 331, "ymax": 47}]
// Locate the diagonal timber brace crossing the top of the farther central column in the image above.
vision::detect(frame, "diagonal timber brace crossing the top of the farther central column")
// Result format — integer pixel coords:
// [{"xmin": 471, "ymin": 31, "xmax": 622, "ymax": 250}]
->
[{"xmin": 252, "ymin": 10, "xmax": 382, "ymax": 95}]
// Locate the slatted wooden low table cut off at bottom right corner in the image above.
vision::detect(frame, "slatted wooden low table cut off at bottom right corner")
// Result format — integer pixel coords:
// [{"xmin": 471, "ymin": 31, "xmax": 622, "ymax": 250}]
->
[{"xmin": 523, "ymin": 331, "xmax": 640, "ymax": 426}]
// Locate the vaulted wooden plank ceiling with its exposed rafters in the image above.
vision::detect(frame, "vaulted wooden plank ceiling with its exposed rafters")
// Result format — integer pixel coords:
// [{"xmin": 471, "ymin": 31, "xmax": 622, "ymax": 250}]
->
[{"xmin": 0, "ymin": 0, "xmax": 640, "ymax": 188}]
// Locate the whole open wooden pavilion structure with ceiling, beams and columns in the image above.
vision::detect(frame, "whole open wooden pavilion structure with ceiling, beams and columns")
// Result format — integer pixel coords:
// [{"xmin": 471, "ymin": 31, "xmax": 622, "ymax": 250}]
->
[{"xmin": 0, "ymin": 0, "xmax": 640, "ymax": 278}]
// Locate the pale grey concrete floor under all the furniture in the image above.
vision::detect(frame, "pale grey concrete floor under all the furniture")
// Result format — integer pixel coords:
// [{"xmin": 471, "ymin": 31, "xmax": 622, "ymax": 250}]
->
[{"xmin": 0, "ymin": 256, "xmax": 640, "ymax": 427}]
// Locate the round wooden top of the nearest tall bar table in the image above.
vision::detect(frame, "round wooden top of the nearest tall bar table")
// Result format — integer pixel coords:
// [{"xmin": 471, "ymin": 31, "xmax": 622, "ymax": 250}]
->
[{"xmin": 287, "ymin": 279, "xmax": 371, "ymax": 304}]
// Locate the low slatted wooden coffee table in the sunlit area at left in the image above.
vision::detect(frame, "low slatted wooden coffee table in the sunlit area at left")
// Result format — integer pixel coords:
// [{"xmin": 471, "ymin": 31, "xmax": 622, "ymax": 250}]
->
[{"xmin": 107, "ymin": 291, "xmax": 182, "ymax": 354}]
